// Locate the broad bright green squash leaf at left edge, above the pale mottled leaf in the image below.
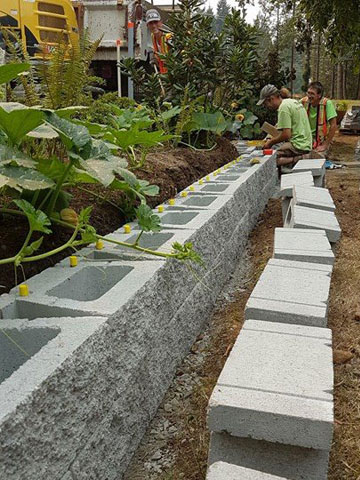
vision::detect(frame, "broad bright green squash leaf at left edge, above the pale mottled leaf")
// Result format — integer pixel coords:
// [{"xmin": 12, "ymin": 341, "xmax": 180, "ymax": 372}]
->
[{"xmin": 0, "ymin": 107, "xmax": 44, "ymax": 146}]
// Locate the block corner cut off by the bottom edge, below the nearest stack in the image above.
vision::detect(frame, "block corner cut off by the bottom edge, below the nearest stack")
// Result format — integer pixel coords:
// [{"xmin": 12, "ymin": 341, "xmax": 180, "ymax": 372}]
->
[{"xmin": 206, "ymin": 462, "xmax": 286, "ymax": 480}]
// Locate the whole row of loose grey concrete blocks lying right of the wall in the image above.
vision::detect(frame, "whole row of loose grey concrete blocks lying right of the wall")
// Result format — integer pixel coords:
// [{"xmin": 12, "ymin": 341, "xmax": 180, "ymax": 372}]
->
[{"xmin": 207, "ymin": 160, "xmax": 341, "ymax": 480}]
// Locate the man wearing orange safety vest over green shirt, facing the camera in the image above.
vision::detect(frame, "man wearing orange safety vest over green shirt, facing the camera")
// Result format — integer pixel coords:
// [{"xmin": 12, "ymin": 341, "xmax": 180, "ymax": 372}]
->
[{"xmin": 301, "ymin": 82, "xmax": 337, "ymax": 155}]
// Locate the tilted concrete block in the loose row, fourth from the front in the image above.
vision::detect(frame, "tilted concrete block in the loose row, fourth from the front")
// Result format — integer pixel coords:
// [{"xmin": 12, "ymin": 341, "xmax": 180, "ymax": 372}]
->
[{"xmin": 284, "ymin": 202, "xmax": 341, "ymax": 243}]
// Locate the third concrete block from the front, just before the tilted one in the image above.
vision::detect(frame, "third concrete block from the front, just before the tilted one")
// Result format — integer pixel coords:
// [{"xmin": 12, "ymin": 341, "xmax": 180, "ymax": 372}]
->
[{"xmin": 273, "ymin": 229, "xmax": 335, "ymax": 265}]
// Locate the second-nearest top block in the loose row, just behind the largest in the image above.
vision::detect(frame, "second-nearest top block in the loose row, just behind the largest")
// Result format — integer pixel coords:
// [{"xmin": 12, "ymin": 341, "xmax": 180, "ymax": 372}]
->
[{"xmin": 245, "ymin": 259, "xmax": 332, "ymax": 327}]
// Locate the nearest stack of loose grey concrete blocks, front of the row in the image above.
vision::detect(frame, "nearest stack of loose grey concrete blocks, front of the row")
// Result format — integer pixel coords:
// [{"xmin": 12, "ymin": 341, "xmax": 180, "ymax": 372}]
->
[{"xmin": 208, "ymin": 320, "xmax": 333, "ymax": 480}]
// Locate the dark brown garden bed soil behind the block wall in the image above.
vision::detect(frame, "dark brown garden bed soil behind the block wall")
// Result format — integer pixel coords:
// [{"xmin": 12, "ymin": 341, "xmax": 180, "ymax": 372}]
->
[{"xmin": 0, "ymin": 138, "xmax": 237, "ymax": 294}]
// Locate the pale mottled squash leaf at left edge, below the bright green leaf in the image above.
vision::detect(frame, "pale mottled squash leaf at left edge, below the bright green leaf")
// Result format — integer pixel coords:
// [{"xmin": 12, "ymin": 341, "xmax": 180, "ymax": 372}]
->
[{"xmin": 0, "ymin": 165, "xmax": 54, "ymax": 192}]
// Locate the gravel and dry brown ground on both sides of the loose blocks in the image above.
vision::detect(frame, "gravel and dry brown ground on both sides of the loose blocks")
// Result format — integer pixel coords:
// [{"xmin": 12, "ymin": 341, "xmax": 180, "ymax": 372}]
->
[{"xmin": 125, "ymin": 135, "xmax": 360, "ymax": 480}]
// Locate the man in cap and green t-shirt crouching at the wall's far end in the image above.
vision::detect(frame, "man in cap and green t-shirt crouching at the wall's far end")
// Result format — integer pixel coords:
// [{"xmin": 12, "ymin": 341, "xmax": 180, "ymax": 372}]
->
[{"xmin": 257, "ymin": 85, "xmax": 312, "ymax": 166}]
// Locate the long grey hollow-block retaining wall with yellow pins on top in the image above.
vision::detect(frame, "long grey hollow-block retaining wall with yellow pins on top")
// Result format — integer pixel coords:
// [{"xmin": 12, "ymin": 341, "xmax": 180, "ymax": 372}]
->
[{"xmin": 0, "ymin": 151, "xmax": 276, "ymax": 480}]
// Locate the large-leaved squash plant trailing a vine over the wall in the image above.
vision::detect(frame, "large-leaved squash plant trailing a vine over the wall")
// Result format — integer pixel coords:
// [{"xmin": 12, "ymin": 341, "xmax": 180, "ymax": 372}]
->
[{"xmin": 0, "ymin": 65, "xmax": 201, "ymax": 278}]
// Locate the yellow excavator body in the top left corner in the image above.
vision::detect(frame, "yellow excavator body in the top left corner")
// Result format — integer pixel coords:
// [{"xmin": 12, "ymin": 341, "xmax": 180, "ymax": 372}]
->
[{"xmin": 0, "ymin": 0, "xmax": 79, "ymax": 56}]
